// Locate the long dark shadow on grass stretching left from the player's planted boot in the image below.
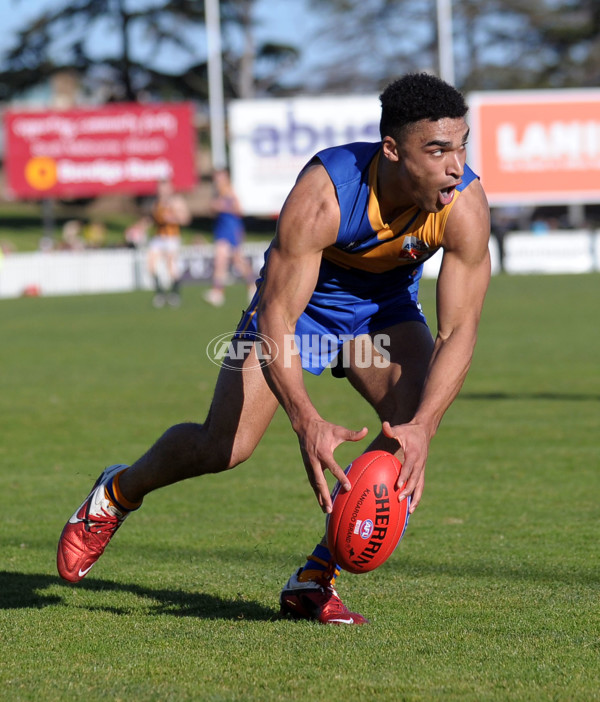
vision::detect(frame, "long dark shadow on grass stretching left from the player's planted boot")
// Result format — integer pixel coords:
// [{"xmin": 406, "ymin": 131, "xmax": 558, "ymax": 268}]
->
[{"xmin": 0, "ymin": 571, "xmax": 278, "ymax": 621}]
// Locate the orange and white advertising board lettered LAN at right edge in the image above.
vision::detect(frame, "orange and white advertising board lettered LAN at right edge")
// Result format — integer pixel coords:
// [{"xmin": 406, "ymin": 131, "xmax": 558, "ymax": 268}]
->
[{"xmin": 468, "ymin": 89, "xmax": 600, "ymax": 205}]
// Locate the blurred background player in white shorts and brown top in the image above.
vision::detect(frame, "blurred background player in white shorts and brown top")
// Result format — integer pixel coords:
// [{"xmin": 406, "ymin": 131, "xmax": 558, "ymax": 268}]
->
[{"xmin": 148, "ymin": 180, "xmax": 191, "ymax": 307}]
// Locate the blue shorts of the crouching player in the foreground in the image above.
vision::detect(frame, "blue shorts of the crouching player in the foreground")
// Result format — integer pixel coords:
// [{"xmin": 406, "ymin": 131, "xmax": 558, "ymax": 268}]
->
[{"xmin": 234, "ymin": 260, "xmax": 427, "ymax": 376}]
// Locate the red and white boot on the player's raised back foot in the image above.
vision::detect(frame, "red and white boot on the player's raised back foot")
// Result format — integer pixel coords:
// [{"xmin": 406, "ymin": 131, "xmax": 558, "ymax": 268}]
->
[{"xmin": 56, "ymin": 464, "xmax": 129, "ymax": 583}]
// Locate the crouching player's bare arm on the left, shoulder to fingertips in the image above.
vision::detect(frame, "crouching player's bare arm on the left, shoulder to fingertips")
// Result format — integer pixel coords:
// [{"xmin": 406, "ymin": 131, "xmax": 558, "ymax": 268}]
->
[{"xmin": 258, "ymin": 165, "xmax": 367, "ymax": 512}]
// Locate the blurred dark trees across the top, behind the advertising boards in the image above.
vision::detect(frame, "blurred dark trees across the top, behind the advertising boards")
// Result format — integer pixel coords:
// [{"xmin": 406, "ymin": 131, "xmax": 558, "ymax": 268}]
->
[{"xmin": 0, "ymin": 0, "xmax": 600, "ymax": 100}]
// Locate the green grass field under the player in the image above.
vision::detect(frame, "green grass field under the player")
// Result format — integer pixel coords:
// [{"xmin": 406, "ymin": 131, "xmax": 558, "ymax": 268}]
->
[{"xmin": 0, "ymin": 275, "xmax": 600, "ymax": 702}]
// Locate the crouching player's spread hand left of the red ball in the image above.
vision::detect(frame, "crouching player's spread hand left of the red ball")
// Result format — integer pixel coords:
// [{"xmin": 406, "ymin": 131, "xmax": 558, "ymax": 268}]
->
[{"xmin": 298, "ymin": 419, "xmax": 368, "ymax": 514}]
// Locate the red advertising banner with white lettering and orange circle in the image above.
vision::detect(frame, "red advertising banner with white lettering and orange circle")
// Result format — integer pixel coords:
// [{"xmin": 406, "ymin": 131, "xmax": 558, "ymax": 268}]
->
[{"xmin": 5, "ymin": 103, "xmax": 196, "ymax": 199}]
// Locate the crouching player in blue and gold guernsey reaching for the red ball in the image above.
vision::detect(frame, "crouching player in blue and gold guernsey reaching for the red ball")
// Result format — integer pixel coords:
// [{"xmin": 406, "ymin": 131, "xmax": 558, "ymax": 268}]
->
[{"xmin": 58, "ymin": 74, "xmax": 490, "ymax": 624}]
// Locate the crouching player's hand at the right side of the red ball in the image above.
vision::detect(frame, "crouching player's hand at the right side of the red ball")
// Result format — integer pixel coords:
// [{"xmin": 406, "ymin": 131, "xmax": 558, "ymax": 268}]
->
[{"xmin": 382, "ymin": 422, "xmax": 429, "ymax": 514}]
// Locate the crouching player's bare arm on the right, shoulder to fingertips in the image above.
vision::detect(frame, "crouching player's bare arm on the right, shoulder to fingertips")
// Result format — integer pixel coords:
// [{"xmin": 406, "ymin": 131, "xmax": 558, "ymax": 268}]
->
[{"xmin": 383, "ymin": 181, "xmax": 490, "ymax": 512}]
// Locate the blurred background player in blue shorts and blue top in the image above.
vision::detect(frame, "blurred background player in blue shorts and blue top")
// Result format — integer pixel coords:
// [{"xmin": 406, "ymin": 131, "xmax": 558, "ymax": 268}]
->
[{"xmin": 204, "ymin": 170, "xmax": 256, "ymax": 307}]
